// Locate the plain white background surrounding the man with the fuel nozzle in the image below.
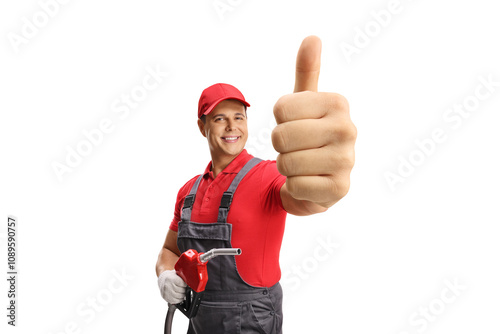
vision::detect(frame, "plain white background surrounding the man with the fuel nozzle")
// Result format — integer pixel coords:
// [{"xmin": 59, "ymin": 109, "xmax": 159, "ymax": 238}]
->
[{"xmin": 0, "ymin": 0, "xmax": 500, "ymax": 334}]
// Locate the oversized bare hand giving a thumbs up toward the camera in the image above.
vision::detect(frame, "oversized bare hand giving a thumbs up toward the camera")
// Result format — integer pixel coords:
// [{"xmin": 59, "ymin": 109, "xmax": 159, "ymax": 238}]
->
[{"xmin": 272, "ymin": 36, "xmax": 357, "ymax": 209}]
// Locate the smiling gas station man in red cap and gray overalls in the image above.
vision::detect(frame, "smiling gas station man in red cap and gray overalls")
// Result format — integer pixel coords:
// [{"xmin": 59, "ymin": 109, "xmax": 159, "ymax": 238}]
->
[{"xmin": 156, "ymin": 36, "xmax": 356, "ymax": 334}]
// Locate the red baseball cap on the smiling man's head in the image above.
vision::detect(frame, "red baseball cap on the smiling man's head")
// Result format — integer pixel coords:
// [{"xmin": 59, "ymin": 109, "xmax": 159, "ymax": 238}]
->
[{"xmin": 198, "ymin": 83, "xmax": 250, "ymax": 118}]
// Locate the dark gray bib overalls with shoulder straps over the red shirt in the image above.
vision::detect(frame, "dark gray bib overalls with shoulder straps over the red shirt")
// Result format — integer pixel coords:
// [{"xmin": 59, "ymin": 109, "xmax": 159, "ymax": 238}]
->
[{"xmin": 177, "ymin": 158, "xmax": 283, "ymax": 334}]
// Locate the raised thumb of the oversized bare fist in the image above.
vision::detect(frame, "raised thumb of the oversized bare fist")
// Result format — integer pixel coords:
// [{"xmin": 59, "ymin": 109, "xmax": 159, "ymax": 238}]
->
[{"xmin": 293, "ymin": 35, "xmax": 321, "ymax": 93}]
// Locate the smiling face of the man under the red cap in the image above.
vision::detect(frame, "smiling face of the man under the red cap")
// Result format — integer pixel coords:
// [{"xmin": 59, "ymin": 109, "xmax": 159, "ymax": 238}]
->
[{"xmin": 198, "ymin": 100, "xmax": 248, "ymax": 158}]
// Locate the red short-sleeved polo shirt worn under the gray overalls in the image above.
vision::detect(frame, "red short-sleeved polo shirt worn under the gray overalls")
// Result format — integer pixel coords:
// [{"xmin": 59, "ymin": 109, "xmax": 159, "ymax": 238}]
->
[{"xmin": 170, "ymin": 150, "xmax": 286, "ymax": 287}]
